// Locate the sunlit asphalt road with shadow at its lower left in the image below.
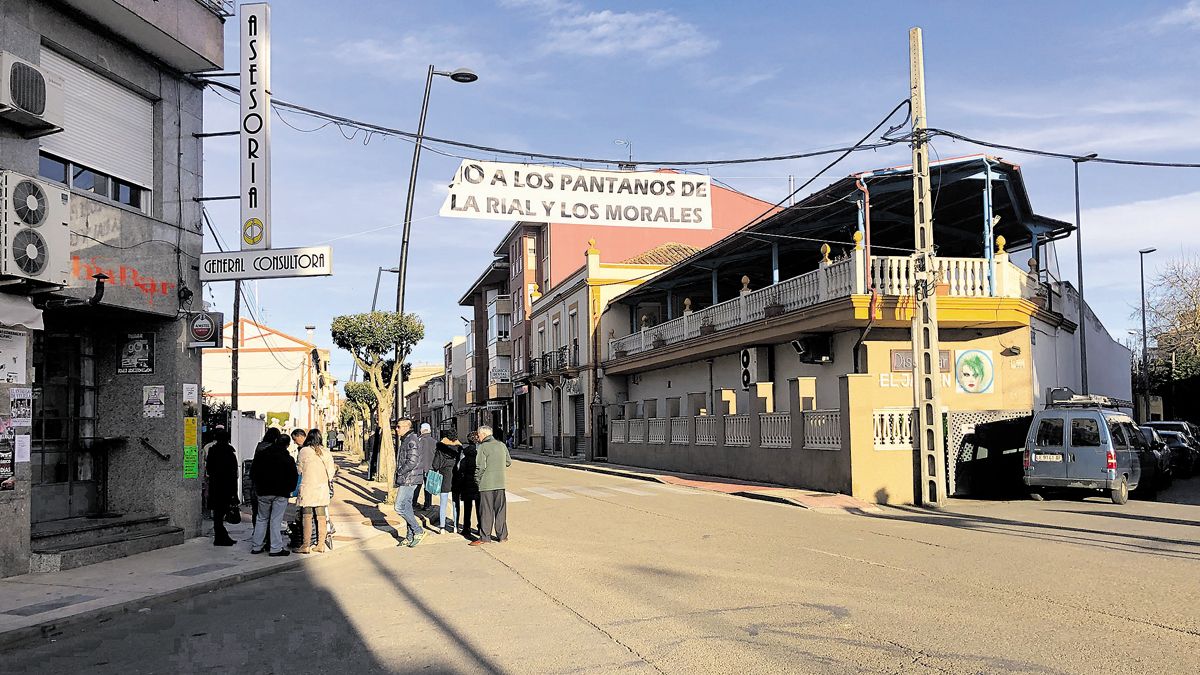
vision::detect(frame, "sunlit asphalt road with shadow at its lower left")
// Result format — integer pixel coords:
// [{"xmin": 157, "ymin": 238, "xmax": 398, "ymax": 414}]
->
[{"xmin": 0, "ymin": 462, "xmax": 1200, "ymax": 674}]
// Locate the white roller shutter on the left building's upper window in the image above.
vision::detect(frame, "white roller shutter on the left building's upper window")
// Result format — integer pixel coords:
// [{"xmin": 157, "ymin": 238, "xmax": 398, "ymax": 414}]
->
[{"xmin": 41, "ymin": 48, "xmax": 154, "ymax": 190}]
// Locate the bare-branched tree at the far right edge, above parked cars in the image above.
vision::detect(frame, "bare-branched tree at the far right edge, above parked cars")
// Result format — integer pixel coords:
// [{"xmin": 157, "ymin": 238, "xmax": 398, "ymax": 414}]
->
[{"xmin": 1146, "ymin": 255, "xmax": 1200, "ymax": 383}]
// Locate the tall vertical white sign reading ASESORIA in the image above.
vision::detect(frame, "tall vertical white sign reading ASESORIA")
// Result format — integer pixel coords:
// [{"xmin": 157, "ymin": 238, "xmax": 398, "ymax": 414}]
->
[{"xmin": 239, "ymin": 2, "xmax": 271, "ymax": 251}]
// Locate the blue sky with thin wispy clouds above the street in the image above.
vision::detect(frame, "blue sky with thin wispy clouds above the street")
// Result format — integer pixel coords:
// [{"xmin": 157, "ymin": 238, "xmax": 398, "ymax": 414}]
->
[{"xmin": 204, "ymin": 0, "xmax": 1200, "ymax": 381}]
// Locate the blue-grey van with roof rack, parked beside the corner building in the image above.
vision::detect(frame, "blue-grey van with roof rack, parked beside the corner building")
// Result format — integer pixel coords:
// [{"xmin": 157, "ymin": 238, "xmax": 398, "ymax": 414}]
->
[{"xmin": 1024, "ymin": 396, "xmax": 1145, "ymax": 504}]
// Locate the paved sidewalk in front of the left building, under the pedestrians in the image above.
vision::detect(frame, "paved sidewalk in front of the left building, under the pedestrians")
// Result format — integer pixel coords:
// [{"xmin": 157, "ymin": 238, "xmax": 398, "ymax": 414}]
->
[{"xmin": 0, "ymin": 455, "xmax": 398, "ymax": 649}]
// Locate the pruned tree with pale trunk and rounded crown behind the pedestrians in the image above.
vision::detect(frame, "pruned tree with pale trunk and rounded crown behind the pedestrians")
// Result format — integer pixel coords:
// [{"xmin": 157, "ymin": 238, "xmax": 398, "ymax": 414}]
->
[{"xmin": 330, "ymin": 312, "xmax": 425, "ymax": 501}]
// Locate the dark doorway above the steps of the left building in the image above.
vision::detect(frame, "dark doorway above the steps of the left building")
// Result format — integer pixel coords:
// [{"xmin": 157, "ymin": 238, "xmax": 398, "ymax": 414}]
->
[{"xmin": 30, "ymin": 331, "xmax": 100, "ymax": 522}]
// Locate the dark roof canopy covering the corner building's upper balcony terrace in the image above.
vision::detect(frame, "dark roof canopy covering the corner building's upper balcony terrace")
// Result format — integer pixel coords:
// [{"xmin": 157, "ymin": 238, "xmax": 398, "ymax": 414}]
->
[{"xmin": 613, "ymin": 155, "xmax": 1074, "ymax": 309}]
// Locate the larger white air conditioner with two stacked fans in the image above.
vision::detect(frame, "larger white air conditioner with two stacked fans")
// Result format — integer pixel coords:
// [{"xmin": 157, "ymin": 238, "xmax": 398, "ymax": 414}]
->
[{"xmin": 0, "ymin": 171, "xmax": 71, "ymax": 286}]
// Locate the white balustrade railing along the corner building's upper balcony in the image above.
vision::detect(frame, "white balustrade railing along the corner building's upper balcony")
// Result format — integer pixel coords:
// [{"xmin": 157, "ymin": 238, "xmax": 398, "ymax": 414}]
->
[{"xmin": 608, "ymin": 250, "xmax": 1037, "ymax": 358}]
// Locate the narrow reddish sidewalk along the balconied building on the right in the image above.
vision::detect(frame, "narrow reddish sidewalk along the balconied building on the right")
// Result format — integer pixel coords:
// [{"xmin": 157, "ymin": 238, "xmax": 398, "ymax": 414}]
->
[{"xmin": 511, "ymin": 450, "xmax": 882, "ymax": 514}]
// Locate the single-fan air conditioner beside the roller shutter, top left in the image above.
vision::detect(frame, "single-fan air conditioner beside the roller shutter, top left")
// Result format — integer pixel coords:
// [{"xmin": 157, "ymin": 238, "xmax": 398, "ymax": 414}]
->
[{"xmin": 0, "ymin": 52, "xmax": 64, "ymax": 138}]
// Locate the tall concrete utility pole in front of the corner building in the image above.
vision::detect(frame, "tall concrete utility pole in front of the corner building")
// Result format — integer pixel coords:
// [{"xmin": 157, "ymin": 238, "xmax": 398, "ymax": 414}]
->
[{"xmin": 908, "ymin": 28, "xmax": 946, "ymax": 507}]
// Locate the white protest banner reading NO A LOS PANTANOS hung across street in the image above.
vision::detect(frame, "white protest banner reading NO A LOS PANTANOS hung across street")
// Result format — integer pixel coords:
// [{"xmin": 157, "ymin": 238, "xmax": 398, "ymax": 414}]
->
[{"xmin": 440, "ymin": 160, "xmax": 713, "ymax": 229}]
